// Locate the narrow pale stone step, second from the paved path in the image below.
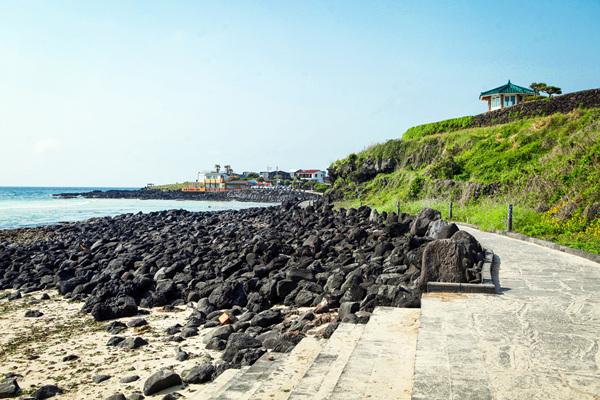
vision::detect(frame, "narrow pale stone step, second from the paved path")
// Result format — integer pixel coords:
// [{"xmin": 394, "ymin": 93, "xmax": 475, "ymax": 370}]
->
[{"xmin": 289, "ymin": 323, "xmax": 365, "ymax": 400}]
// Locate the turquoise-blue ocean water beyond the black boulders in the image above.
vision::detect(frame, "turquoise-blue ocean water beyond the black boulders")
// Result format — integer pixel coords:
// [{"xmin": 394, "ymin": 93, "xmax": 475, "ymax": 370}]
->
[{"xmin": 0, "ymin": 186, "xmax": 266, "ymax": 229}]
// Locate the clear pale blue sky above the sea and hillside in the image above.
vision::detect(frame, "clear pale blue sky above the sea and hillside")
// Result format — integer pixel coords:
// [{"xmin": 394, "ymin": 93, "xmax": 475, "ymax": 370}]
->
[{"xmin": 0, "ymin": 0, "xmax": 600, "ymax": 186}]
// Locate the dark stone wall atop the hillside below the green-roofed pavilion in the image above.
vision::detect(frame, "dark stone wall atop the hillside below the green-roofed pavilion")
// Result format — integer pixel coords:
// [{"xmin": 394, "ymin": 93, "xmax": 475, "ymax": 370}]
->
[{"xmin": 472, "ymin": 89, "xmax": 600, "ymax": 127}]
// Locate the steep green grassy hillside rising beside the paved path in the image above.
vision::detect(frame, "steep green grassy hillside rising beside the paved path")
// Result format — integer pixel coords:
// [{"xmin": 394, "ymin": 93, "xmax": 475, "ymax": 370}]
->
[{"xmin": 328, "ymin": 90, "xmax": 600, "ymax": 254}]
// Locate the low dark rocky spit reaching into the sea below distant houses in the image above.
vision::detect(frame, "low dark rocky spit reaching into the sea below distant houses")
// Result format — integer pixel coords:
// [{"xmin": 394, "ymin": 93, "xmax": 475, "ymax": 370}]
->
[{"xmin": 53, "ymin": 189, "xmax": 321, "ymax": 203}]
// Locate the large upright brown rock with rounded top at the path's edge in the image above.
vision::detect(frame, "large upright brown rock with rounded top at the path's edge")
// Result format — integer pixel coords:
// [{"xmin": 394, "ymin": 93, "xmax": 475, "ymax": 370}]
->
[{"xmin": 417, "ymin": 239, "xmax": 467, "ymax": 289}]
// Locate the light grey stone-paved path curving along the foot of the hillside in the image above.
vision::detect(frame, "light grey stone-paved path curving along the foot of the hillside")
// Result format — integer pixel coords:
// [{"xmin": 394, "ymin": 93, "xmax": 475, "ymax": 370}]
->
[{"xmin": 412, "ymin": 227, "xmax": 600, "ymax": 400}]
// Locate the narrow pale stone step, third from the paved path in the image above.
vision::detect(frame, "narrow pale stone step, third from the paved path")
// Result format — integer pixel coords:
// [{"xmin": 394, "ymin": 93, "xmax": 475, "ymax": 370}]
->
[{"xmin": 250, "ymin": 337, "xmax": 325, "ymax": 400}]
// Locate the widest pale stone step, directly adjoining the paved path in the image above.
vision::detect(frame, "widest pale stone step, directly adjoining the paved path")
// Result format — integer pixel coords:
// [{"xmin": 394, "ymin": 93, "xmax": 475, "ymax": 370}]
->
[{"xmin": 329, "ymin": 307, "xmax": 420, "ymax": 400}]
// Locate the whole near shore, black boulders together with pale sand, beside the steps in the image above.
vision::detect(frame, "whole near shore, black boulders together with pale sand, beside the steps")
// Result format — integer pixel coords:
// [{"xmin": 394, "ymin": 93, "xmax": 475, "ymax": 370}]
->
[{"xmin": 0, "ymin": 201, "xmax": 485, "ymax": 398}]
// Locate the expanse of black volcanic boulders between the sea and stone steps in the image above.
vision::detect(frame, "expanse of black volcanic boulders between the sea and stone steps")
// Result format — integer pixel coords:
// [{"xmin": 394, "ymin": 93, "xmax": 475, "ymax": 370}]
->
[{"xmin": 0, "ymin": 201, "xmax": 484, "ymax": 398}]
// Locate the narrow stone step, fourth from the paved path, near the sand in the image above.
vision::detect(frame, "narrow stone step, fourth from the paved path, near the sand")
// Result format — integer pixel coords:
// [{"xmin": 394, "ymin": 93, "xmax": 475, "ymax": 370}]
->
[{"xmin": 208, "ymin": 352, "xmax": 291, "ymax": 400}]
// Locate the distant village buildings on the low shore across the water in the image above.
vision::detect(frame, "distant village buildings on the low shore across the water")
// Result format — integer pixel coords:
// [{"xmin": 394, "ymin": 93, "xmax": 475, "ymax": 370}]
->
[{"xmin": 169, "ymin": 164, "xmax": 329, "ymax": 192}]
